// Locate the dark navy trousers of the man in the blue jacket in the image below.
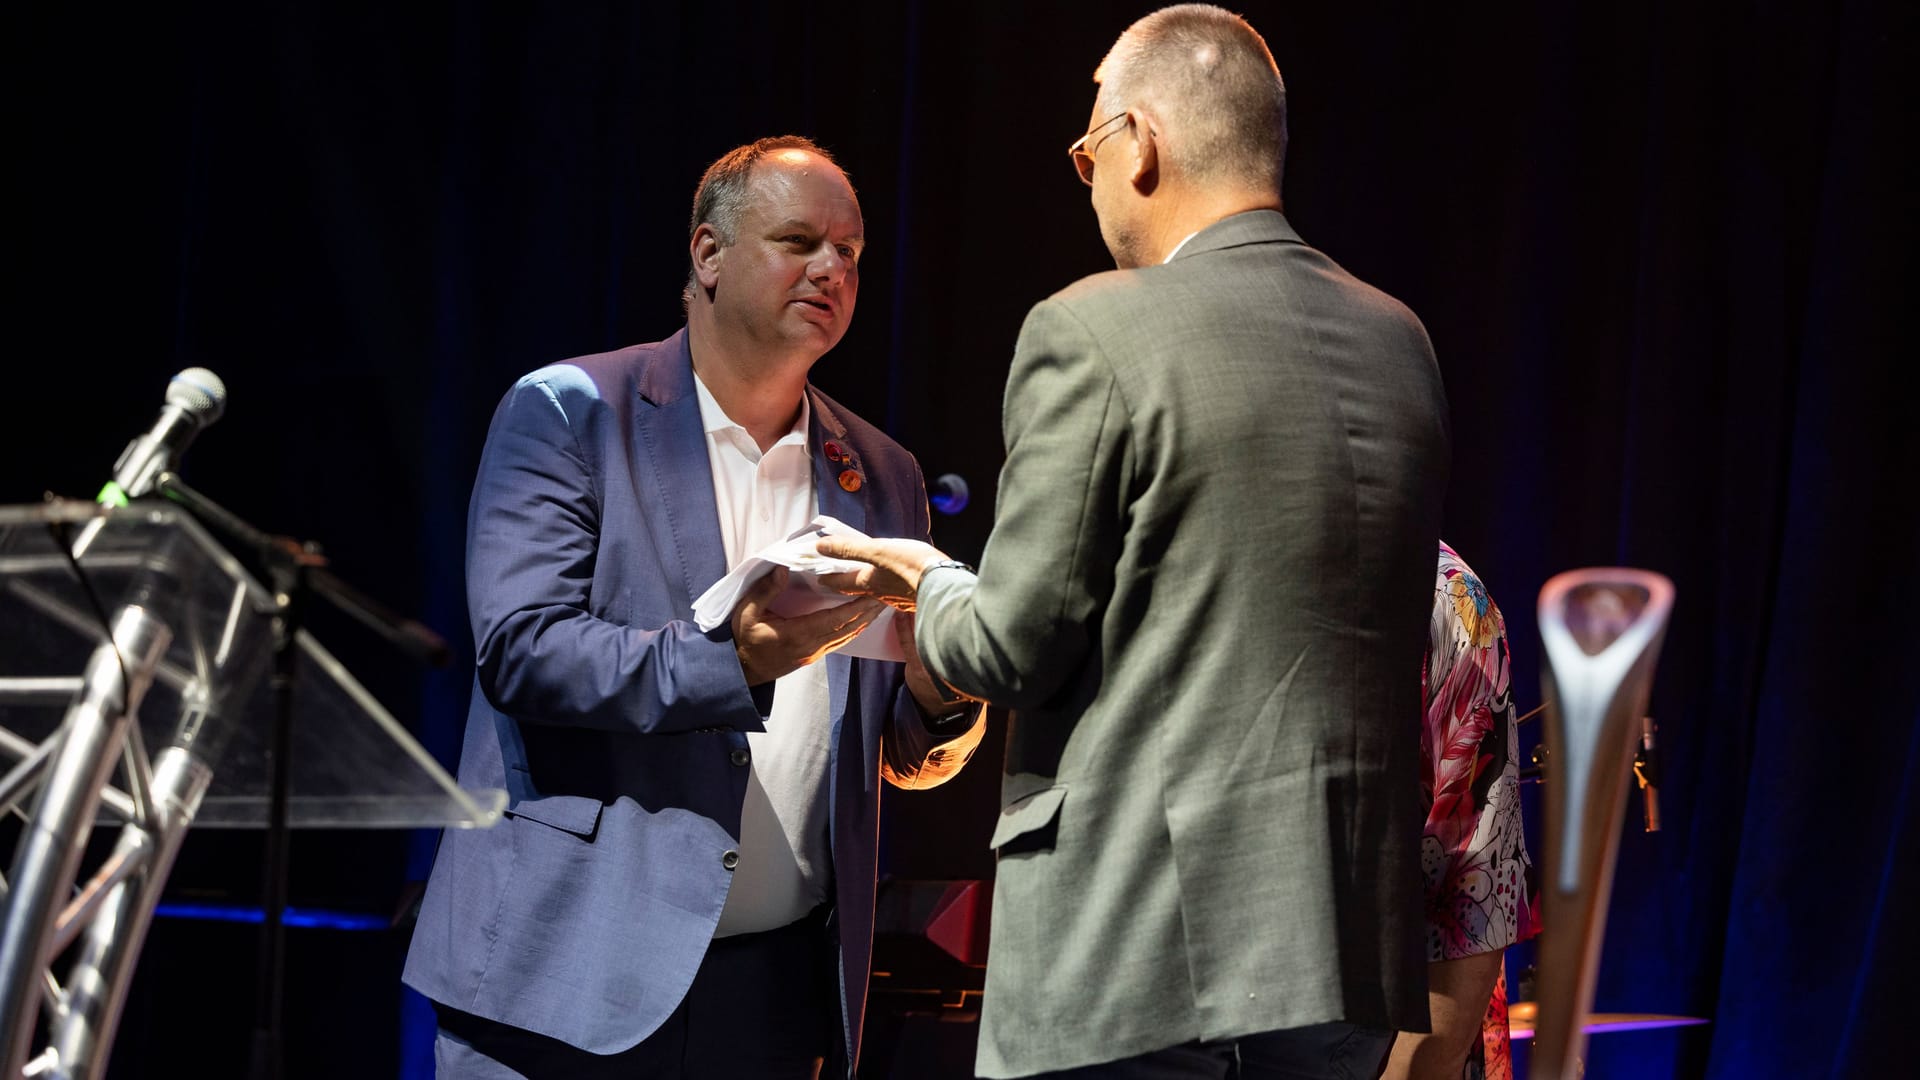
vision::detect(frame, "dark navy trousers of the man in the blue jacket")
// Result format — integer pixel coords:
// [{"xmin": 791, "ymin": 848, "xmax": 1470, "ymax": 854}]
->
[{"xmin": 434, "ymin": 911, "xmax": 845, "ymax": 1080}]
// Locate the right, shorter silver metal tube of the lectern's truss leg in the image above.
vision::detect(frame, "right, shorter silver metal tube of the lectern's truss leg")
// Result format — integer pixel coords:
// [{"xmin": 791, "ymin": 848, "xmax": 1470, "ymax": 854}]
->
[{"xmin": 52, "ymin": 746, "xmax": 213, "ymax": 1080}]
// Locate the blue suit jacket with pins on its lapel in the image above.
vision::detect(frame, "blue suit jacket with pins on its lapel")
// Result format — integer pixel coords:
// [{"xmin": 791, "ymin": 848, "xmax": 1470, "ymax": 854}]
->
[{"xmin": 403, "ymin": 331, "xmax": 981, "ymax": 1063}]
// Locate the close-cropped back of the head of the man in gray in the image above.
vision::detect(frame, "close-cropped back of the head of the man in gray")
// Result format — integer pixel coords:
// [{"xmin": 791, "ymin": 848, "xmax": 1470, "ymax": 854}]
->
[{"xmin": 1092, "ymin": 4, "xmax": 1286, "ymax": 196}]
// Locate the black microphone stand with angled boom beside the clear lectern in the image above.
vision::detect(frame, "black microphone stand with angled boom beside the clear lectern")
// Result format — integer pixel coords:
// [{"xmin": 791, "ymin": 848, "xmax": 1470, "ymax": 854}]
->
[{"xmin": 154, "ymin": 471, "xmax": 453, "ymax": 1080}]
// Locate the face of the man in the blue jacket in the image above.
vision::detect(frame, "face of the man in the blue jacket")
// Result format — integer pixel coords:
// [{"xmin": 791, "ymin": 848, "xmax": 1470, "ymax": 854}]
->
[{"xmin": 712, "ymin": 150, "xmax": 866, "ymax": 359}]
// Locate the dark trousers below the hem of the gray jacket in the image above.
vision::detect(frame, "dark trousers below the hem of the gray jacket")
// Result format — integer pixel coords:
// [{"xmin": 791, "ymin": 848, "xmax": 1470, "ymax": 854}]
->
[{"xmin": 1035, "ymin": 1024, "xmax": 1394, "ymax": 1080}]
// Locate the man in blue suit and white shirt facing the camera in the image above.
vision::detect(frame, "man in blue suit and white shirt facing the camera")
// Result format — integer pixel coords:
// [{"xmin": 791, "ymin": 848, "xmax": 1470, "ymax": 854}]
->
[{"xmin": 405, "ymin": 136, "xmax": 983, "ymax": 1080}]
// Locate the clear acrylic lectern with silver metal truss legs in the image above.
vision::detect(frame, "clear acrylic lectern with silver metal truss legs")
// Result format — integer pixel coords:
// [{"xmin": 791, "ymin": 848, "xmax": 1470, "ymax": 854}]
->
[{"xmin": 0, "ymin": 502, "xmax": 507, "ymax": 1080}]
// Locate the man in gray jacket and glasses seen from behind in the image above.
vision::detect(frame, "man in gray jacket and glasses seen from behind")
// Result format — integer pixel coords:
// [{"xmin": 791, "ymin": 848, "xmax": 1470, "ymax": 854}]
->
[{"xmin": 822, "ymin": 6, "xmax": 1450, "ymax": 1076}]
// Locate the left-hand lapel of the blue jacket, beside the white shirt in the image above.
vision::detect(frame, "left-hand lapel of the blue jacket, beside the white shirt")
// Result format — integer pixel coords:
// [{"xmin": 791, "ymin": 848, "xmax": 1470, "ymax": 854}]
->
[{"xmin": 634, "ymin": 329, "xmax": 726, "ymax": 613}]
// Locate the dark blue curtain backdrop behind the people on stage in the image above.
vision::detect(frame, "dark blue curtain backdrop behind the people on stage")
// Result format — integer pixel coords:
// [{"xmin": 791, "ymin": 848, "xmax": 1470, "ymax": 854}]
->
[{"xmin": 11, "ymin": 0, "xmax": 1920, "ymax": 1078}]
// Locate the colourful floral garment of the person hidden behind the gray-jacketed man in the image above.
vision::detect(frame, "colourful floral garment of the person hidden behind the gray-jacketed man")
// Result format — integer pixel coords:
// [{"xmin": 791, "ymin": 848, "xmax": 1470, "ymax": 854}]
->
[{"xmin": 1421, "ymin": 542, "xmax": 1540, "ymax": 1080}]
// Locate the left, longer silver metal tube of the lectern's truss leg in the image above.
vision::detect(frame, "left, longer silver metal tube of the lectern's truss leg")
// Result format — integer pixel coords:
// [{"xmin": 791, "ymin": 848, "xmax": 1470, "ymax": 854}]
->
[{"xmin": 0, "ymin": 605, "xmax": 171, "ymax": 1076}]
